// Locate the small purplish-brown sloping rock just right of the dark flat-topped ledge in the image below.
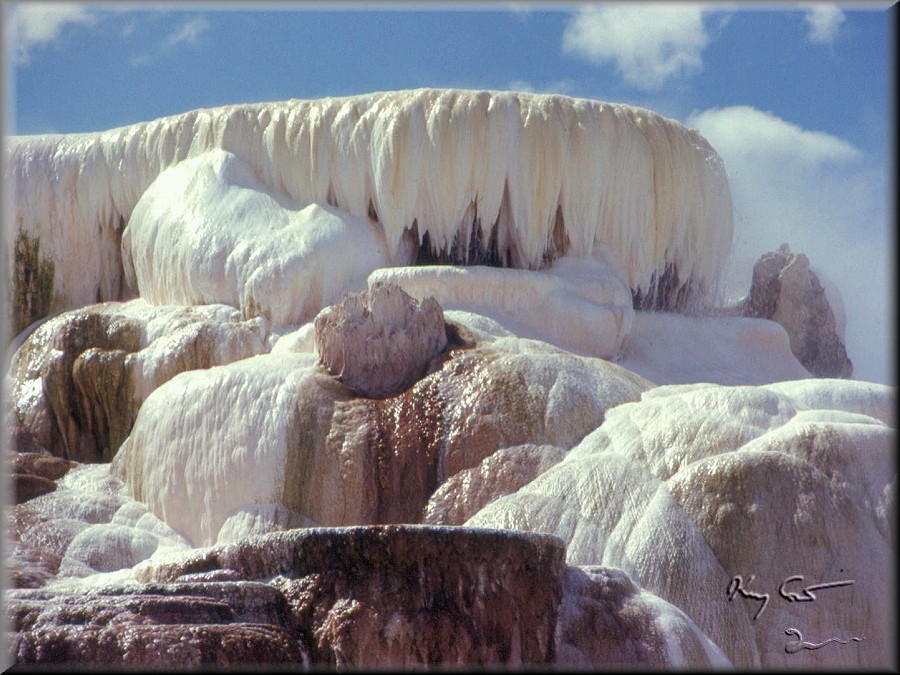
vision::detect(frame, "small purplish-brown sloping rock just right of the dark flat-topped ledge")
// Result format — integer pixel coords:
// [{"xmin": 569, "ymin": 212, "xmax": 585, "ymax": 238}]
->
[{"xmin": 555, "ymin": 566, "xmax": 731, "ymax": 670}]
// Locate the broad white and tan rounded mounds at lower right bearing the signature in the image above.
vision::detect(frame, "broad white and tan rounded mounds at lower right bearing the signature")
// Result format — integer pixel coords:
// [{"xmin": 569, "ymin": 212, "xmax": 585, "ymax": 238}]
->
[{"xmin": 466, "ymin": 379, "xmax": 897, "ymax": 668}]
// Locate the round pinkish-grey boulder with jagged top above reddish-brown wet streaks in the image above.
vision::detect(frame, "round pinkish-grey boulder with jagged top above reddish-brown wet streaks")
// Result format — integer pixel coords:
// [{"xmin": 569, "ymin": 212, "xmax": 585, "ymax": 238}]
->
[{"xmin": 315, "ymin": 283, "xmax": 447, "ymax": 398}]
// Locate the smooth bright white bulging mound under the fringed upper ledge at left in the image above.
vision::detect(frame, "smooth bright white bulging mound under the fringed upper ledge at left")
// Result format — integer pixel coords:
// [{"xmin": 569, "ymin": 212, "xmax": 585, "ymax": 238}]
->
[{"xmin": 121, "ymin": 152, "xmax": 391, "ymax": 328}]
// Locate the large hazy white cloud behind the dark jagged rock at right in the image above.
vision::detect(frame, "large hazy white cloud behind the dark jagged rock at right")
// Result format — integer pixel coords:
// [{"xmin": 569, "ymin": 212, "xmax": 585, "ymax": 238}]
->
[{"xmin": 687, "ymin": 106, "xmax": 894, "ymax": 382}]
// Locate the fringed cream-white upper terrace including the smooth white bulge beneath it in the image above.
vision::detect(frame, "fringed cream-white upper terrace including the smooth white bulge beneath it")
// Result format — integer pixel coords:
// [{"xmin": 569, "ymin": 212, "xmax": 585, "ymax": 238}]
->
[{"xmin": 5, "ymin": 89, "xmax": 732, "ymax": 327}]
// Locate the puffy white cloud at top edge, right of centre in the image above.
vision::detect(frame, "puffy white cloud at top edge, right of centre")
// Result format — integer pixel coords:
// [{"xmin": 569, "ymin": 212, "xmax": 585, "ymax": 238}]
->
[{"xmin": 563, "ymin": 3, "xmax": 709, "ymax": 90}]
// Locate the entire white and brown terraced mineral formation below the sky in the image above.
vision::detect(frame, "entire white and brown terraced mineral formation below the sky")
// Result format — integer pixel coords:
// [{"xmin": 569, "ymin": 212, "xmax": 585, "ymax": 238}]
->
[{"xmin": 4, "ymin": 89, "xmax": 897, "ymax": 669}]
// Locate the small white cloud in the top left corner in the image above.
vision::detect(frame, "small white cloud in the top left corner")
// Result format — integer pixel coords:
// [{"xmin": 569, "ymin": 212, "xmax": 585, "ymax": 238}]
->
[{"xmin": 5, "ymin": 2, "xmax": 97, "ymax": 65}]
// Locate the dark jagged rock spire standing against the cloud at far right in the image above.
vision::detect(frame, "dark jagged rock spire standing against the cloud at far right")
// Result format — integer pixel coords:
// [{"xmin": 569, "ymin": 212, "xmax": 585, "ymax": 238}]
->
[{"xmin": 746, "ymin": 244, "xmax": 853, "ymax": 377}]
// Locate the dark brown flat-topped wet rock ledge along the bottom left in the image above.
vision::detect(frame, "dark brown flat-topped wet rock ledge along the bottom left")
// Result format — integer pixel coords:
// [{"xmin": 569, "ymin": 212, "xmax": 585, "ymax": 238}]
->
[{"xmin": 7, "ymin": 526, "xmax": 565, "ymax": 668}]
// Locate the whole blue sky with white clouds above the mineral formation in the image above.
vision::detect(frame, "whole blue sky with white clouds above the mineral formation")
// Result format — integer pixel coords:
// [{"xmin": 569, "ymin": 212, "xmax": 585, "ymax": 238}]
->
[{"xmin": 3, "ymin": 2, "xmax": 896, "ymax": 381}]
